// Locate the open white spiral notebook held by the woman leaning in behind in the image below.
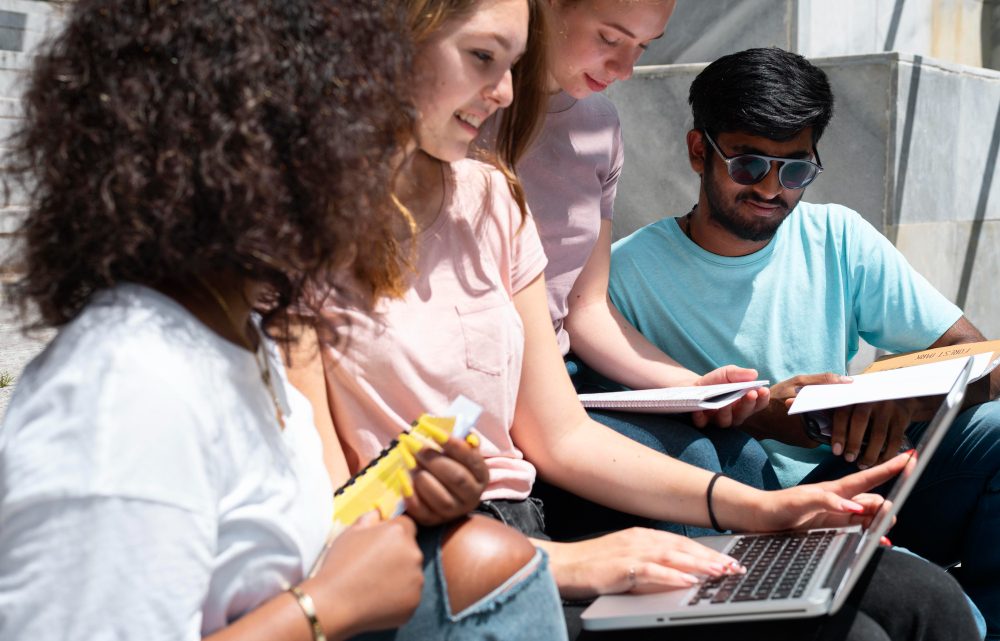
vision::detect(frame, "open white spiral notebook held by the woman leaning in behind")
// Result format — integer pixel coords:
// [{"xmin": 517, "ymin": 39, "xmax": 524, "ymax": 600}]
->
[{"xmin": 579, "ymin": 381, "xmax": 768, "ymax": 414}]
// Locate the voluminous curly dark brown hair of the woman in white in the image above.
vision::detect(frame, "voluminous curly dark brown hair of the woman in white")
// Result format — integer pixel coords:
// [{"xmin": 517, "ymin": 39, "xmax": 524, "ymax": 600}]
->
[{"xmin": 7, "ymin": 0, "xmax": 413, "ymax": 336}]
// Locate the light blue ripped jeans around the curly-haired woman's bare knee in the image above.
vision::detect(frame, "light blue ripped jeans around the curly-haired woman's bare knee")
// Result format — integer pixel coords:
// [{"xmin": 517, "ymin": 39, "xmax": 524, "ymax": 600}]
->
[{"xmin": 352, "ymin": 527, "xmax": 566, "ymax": 641}]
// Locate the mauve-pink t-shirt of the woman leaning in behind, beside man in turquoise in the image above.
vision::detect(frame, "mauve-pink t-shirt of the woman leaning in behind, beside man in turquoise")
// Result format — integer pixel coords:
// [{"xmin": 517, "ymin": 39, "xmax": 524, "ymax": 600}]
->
[{"xmin": 517, "ymin": 92, "xmax": 624, "ymax": 354}]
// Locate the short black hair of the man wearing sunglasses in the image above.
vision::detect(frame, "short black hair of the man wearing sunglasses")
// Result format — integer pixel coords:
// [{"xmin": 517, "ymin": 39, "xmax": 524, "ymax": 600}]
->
[{"xmin": 688, "ymin": 47, "xmax": 833, "ymax": 143}]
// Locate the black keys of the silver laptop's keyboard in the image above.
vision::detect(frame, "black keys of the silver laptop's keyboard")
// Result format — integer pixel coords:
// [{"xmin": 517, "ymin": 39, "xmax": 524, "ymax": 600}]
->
[{"xmin": 688, "ymin": 530, "xmax": 837, "ymax": 605}]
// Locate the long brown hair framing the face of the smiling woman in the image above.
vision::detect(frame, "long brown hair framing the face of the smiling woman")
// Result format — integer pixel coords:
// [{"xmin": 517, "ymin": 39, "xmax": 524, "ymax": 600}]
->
[{"xmin": 403, "ymin": 0, "xmax": 548, "ymax": 220}]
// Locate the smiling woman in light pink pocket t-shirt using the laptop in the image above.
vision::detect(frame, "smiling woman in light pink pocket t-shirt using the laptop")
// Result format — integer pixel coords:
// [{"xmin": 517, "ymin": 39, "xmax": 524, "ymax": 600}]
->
[{"xmin": 293, "ymin": 0, "xmax": 972, "ymax": 620}]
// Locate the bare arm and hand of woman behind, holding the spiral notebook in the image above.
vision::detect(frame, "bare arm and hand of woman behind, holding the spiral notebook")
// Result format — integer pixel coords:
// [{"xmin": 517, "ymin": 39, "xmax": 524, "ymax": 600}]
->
[{"xmin": 565, "ymin": 220, "xmax": 767, "ymax": 427}]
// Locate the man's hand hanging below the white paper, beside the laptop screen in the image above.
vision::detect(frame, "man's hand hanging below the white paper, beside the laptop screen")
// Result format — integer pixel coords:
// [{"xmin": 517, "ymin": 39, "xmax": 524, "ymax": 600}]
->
[{"xmin": 830, "ymin": 398, "xmax": 922, "ymax": 470}]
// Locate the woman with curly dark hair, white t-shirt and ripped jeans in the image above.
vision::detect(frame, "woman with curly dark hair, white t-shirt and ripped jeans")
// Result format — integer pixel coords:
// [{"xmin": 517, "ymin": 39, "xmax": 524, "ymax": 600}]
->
[{"xmin": 0, "ymin": 0, "xmax": 564, "ymax": 640}]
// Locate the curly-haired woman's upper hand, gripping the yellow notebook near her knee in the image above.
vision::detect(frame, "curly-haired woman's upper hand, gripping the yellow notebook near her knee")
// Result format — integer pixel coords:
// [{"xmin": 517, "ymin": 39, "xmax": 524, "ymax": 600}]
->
[{"xmin": 406, "ymin": 437, "xmax": 490, "ymax": 525}]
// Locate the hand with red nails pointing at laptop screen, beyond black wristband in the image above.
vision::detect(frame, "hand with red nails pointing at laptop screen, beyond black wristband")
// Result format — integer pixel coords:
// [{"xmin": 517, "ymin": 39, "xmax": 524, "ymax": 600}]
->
[{"xmin": 748, "ymin": 454, "xmax": 909, "ymax": 532}]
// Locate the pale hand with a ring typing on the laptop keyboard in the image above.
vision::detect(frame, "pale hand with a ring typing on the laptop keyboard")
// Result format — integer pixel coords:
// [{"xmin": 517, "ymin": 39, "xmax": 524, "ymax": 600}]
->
[{"xmin": 546, "ymin": 528, "xmax": 746, "ymax": 599}]
